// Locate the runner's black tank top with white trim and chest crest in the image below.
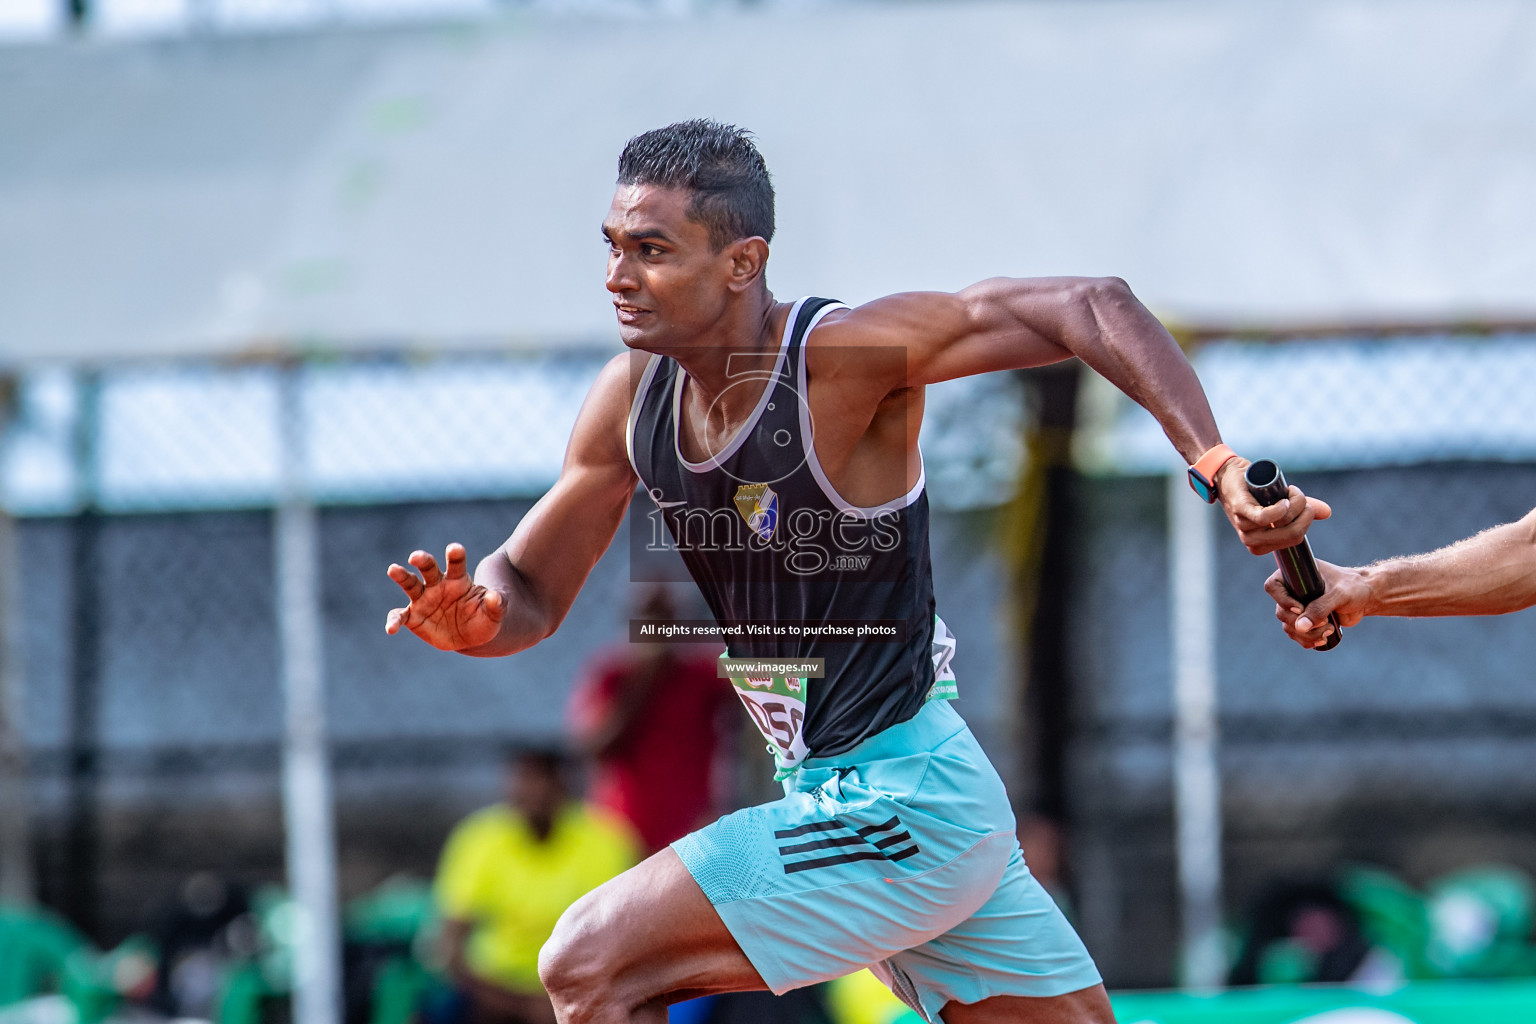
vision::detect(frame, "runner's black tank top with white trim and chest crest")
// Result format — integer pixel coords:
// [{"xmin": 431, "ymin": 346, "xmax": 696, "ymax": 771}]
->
[{"xmin": 628, "ymin": 291, "xmax": 955, "ymax": 768}]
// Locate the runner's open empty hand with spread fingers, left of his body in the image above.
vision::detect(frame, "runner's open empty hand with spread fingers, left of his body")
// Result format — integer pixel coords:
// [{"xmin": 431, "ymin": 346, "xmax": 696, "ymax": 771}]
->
[{"xmin": 384, "ymin": 543, "xmax": 507, "ymax": 651}]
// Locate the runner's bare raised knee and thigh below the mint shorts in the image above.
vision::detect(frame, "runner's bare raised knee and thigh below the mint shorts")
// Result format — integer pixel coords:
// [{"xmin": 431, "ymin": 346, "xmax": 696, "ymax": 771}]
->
[{"xmin": 539, "ymin": 849, "xmax": 765, "ymax": 1009}]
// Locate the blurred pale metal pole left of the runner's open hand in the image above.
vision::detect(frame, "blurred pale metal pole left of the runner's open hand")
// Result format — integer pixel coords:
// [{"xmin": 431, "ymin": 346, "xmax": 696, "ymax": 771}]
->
[{"xmin": 273, "ymin": 365, "xmax": 341, "ymax": 1024}]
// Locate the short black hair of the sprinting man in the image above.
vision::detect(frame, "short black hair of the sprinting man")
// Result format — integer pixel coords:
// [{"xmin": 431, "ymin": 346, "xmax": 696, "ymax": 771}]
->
[{"xmin": 619, "ymin": 118, "xmax": 773, "ymax": 252}]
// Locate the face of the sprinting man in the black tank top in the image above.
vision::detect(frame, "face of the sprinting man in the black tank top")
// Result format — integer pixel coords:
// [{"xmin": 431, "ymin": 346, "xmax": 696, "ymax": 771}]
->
[{"xmin": 602, "ymin": 184, "xmax": 733, "ymax": 352}]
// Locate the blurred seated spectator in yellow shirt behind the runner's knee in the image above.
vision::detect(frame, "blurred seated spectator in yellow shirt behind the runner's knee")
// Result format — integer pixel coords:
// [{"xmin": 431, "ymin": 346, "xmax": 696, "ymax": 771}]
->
[{"xmin": 436, "ymin": 749, "xmax": 639, "ymax": 1024}]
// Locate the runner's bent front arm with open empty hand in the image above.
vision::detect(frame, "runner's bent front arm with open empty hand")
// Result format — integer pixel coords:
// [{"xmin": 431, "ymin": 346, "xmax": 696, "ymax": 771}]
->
[{"xmin": 384, "ymin": 355, "xmax": 648, "ymax": 657}]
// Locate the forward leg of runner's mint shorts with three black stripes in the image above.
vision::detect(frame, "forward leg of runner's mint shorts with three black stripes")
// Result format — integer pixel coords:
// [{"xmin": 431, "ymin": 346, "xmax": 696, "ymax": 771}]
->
[{"xmin": 673, "ymin": 752, "xmax": 1017, "ymax": 1009}]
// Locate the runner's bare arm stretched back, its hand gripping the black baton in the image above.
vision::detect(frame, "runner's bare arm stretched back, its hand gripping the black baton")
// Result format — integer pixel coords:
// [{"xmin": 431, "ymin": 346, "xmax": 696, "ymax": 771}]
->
[{"xmin": 823, "ymin": 278, "xmax": 1329, "ymax": 554}]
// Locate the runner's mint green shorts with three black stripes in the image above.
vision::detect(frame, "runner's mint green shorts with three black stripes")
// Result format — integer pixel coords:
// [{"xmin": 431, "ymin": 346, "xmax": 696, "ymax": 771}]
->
[{"xmin": 673, "ymin": 700, "xmax": 1100, "ymax": 1022}]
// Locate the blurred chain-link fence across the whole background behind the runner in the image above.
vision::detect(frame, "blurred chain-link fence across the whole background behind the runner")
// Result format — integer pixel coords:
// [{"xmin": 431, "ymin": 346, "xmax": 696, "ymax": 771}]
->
[{"xmin": 0, "ymin": 333, "xmax": 1536, "ymax": 1007}]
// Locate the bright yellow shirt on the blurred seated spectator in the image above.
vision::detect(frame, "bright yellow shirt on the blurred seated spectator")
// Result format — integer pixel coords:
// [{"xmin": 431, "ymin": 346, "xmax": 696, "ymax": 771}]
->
[{"xmin": 435, "ymin": 803, "xmax": 639, "ymax": 992}]
